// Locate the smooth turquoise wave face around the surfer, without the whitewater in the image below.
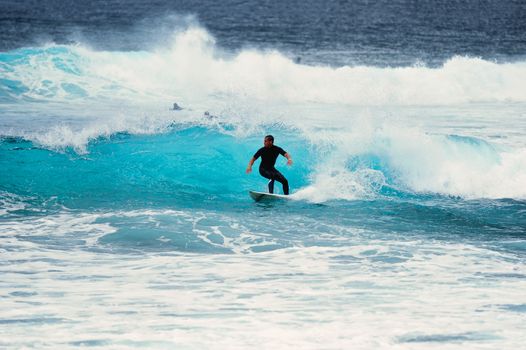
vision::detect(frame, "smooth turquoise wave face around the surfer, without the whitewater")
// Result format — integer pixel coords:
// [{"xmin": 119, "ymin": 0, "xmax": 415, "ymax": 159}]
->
[{"xmin": 0, "ymin": 127, "xmax": 312, "ymax": 206}]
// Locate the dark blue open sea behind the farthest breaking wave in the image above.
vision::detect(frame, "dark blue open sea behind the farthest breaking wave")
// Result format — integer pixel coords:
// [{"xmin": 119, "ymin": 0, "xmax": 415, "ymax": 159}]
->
[{"xmin": 0, "ymin": 0, "xmax": 526, "ymax": 66}]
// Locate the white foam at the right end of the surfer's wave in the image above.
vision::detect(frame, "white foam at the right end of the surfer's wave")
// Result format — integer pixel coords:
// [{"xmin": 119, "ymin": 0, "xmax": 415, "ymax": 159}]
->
[{"xmin": 382, "ymin": 128, "xmax": 526, "ymax": 198}]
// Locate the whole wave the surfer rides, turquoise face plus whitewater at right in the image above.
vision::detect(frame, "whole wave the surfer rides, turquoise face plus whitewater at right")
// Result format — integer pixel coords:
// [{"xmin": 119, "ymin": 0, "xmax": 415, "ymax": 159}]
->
[{"xmin": 1, "ymin": 125, "xmax": 526, "ymax": 202}]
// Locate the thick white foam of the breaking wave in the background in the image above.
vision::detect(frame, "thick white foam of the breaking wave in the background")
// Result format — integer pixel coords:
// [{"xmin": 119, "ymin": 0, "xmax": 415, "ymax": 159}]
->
[{"xmin": 83, "ymin": 32, "xmax": 526, "ymax": 105}]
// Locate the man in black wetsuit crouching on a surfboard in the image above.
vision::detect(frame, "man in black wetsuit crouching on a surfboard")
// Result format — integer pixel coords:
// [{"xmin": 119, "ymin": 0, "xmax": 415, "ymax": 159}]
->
[{"xmin": 246, "ymin": 135, "xmax": 292, "ymax": 195}]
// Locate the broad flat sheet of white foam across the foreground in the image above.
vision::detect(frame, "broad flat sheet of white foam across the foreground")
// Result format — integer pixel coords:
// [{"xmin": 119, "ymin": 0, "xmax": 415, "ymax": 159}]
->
[{"xmin": 0, "ymin": 236, "xmax": 526, "ymax": 349}]
